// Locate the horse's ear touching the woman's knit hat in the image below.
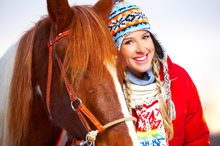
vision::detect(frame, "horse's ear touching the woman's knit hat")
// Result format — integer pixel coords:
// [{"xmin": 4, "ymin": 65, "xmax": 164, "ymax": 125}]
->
[{"xmin": 93, "ymin": 0, "xmax": 114, "ymax": 24}]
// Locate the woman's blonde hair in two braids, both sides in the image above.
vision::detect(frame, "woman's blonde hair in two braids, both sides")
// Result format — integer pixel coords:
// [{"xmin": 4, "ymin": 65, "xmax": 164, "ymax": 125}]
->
[{"xmin": 124, "ymin": 55, "xmax": 173, "ymax": 140}]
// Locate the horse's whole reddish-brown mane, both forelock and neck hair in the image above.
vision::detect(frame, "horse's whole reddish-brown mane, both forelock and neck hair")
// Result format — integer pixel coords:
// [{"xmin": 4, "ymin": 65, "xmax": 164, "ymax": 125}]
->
[{"xmin": 7, "ymin": 6, "xmax": 117, "ymax": 146}]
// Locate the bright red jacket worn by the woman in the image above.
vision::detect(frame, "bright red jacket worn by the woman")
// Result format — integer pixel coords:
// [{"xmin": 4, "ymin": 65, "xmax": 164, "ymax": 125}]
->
[{"xmin": 160, "ymin": 57, "xmax": 210, "ymax": 146}]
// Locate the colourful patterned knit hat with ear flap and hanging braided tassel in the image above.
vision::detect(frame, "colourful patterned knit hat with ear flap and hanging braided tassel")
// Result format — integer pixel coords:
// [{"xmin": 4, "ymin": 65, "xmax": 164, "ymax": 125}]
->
[{"xmin": 108, "ymin": 0, "xmax": 176, "ymax": 122}]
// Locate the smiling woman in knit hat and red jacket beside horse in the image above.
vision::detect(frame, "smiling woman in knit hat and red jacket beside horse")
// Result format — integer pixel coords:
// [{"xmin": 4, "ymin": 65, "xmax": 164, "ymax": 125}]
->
[{"xmin": 108, "ymin": 0, "xmax": 210, "ymax": 146}]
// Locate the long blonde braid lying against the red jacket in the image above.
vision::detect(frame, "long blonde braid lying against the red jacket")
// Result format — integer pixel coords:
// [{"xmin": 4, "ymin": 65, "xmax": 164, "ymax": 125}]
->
[{"xmin": 152, "ymin": 55, "xmax": 173, "ymax": 140}]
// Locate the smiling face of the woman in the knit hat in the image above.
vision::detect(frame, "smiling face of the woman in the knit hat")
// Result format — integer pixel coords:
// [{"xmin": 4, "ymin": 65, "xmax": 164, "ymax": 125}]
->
[{"xmin": 121, "ymin": 30, "xmax": 155, "ymax": 79}]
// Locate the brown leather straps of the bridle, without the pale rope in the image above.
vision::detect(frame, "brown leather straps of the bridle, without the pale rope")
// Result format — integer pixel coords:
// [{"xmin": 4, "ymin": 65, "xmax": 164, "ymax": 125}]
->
[{"xmin": 46, "ymin": 30, "xmax": 104, "ymax": 132}]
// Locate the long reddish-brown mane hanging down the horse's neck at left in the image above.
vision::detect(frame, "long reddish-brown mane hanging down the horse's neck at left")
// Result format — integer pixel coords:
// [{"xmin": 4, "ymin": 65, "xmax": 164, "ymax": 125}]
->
[{"xmin": 7, "ymin": 17, "xmax": 45, "ymax": 146}]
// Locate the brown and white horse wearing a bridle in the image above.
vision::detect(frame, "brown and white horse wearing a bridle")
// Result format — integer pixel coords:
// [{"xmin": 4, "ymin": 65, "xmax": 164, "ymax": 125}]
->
[{"xmin": 0, "ymin": 0, "xmax": 139, "ymax": 146}]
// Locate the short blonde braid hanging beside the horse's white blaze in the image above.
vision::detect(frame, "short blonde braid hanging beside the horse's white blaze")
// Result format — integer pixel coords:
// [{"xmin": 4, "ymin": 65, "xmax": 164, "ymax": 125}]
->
[{"xmin": 124, "ymin": 71, "xmax": 132, "ymax": 114}]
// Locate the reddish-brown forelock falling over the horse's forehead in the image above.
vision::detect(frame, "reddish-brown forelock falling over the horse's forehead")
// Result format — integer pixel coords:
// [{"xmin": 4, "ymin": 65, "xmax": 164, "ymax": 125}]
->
[{"xmin": 63, "ymin": 6, "xmax": 117, "ymax": 87}]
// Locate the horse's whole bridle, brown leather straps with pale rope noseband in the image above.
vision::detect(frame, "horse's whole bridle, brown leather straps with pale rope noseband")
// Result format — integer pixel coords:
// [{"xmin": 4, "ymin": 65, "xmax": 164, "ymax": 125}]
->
[{"xmin": 46, "ymin": 27, "xmax": 137, "ymax": 145}]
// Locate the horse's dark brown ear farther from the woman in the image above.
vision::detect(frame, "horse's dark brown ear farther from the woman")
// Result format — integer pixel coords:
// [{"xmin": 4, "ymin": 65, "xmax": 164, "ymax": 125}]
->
[{"xmin": 47, "ymin": 0, "xmax": 72, "ymax": 33}]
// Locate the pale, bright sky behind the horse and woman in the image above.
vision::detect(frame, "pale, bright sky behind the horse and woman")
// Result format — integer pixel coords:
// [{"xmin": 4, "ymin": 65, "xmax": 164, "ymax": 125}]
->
[{"xmin": 0, "ymin": 0, "xmax": 220, "ymax": 134}]
